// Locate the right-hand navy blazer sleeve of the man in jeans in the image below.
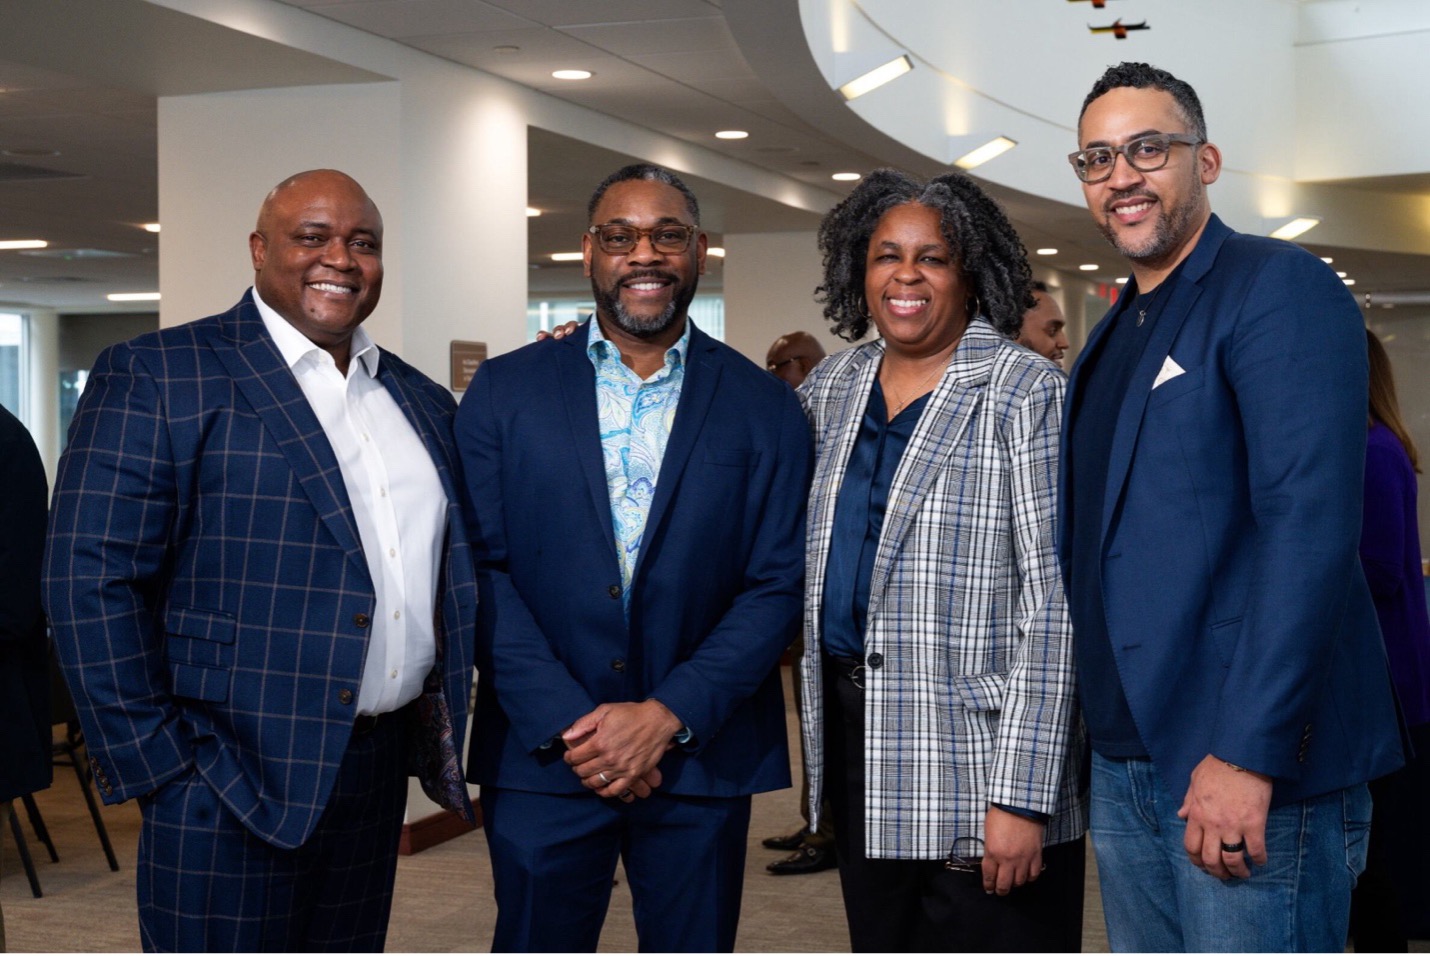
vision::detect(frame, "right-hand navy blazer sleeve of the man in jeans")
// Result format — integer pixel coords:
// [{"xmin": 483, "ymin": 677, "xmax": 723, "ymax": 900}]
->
[{"xmin": 1211, "ymin": 250, "xmax": 1367, "ymax": 779}]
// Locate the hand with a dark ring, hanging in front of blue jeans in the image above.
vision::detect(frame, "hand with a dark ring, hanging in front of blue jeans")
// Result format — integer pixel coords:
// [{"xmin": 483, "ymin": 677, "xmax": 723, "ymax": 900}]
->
[{"xmin": 1177, "ymin": 753, "xmax": 1271, "ymax": 880}]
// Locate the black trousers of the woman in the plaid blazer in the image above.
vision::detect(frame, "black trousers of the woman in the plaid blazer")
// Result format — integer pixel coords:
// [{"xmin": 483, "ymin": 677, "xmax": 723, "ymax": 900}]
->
[{"xmin": 825, "ymin": 659, "xmax": 1085, "ymax": 953}]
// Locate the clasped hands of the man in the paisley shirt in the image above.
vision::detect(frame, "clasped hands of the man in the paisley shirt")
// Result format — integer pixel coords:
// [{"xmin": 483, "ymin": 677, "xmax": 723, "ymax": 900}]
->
[{"xmin": 562, "ymin": 700, "xmax": 681, "ymax": 799}]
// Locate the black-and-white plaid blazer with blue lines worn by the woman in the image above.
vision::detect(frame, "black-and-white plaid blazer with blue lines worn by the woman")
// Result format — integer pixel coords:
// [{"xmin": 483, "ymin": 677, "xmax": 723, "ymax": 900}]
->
[{"xmin": 799, "ymin": 319, "xmax": 1087, "ymax": 859}]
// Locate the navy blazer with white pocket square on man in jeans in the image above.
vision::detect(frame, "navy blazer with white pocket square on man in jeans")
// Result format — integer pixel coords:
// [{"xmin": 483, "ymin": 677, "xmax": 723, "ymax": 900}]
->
[{"xmin": 1060, "ymin": 216, "xmax": 1401, "ymax": 805}]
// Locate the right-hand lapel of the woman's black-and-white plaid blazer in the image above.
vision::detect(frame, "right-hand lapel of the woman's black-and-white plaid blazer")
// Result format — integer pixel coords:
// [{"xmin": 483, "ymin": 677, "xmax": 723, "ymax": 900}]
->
[{"xmin": 868, "ymin": 320, "xmax": 1001, "ymax": 617}]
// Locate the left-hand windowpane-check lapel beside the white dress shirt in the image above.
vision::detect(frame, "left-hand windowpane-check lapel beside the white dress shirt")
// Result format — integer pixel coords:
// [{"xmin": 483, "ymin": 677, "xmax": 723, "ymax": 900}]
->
[{"xmin": 215, "ymin": 294, "xmax": 368, "ymax": 573}]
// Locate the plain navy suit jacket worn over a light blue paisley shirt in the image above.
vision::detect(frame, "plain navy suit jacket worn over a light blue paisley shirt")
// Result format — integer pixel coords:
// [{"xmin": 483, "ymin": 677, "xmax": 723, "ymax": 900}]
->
[{"xmin": 456, "ymin": 327, "xmax": 811, "ymax": 796}]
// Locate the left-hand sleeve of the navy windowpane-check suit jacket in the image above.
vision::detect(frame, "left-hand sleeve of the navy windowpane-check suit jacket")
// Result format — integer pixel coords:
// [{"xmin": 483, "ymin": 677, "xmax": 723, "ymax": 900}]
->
[{"xmin": 46, "ymin": 338, "xmax": 192, "ymax": 802}]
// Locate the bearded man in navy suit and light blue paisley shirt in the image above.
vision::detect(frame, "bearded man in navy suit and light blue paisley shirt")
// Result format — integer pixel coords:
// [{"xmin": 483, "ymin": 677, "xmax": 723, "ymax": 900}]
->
[{"xmin": 456, "ymin": 166, "xmax": 811, "ymax": 952}]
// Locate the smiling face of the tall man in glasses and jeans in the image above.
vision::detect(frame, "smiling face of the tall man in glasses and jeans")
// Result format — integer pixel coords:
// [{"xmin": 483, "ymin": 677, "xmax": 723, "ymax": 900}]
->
[{"xmin": 1078, "ymin": 86, "xmax": 1221, "ymax": 282}]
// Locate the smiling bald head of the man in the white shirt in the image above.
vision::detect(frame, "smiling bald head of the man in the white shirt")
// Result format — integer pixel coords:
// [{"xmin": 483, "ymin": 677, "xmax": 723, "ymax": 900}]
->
[{"xmin": 249, "ymin": 170, "xmax": 382, "ymax": 372}]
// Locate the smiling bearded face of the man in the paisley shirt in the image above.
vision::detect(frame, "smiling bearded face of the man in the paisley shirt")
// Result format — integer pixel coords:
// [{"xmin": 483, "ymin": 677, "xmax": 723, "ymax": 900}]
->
[{"xmin": 582, "ymin": 179, "xmax": 708, "ymax": 344}]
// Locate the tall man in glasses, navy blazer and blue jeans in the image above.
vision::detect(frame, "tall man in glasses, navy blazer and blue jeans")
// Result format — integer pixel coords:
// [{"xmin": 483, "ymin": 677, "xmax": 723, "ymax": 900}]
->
[{"xmin": 1060, "ymin": 63, "xmax": 1400, "ymax": 952}]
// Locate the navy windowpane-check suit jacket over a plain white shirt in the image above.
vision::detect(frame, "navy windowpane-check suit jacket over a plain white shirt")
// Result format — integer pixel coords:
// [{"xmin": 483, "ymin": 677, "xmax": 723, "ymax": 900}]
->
[{"xmin": 46, "ymin": 294, "xmax": 476, "ymax": 847}]
